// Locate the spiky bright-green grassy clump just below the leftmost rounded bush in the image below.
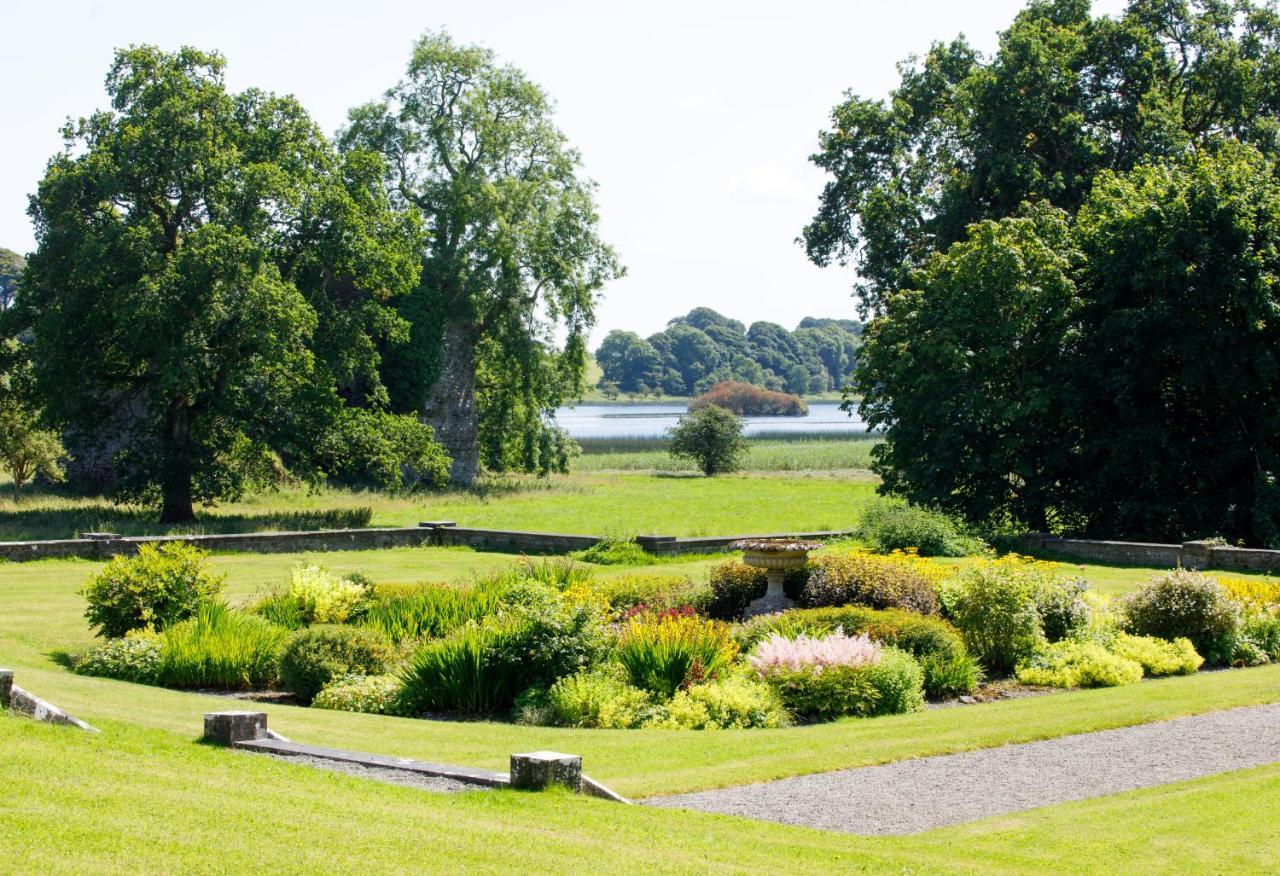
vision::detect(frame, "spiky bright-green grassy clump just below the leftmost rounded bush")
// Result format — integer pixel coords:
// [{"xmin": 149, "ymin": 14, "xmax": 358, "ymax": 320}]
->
[{"xmin": 159, "ymin": 602, "xmax": 288, "ymax": 690}]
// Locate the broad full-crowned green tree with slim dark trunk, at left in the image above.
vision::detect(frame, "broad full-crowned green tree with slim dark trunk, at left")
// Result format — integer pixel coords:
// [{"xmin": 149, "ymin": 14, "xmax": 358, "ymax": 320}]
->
[{"xmin": 17, "ymin": 46, "xmax": 419, "ymax": 521}]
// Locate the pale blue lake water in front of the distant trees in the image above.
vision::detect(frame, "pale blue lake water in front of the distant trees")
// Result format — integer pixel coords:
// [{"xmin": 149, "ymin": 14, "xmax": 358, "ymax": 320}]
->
[{"xmin": 556, "ymin": 402, "xmax": 867, "ymax": 438}]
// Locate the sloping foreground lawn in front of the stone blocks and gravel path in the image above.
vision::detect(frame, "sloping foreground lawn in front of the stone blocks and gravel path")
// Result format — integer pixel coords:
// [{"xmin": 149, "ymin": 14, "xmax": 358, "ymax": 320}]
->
[{"xmin": 0, "ymin": 716, "xmax": 1280, "ymax": 873}]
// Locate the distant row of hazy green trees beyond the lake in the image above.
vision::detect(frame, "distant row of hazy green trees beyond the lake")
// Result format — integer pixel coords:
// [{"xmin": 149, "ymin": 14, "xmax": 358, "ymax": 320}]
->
[{"xmin": 595, "ymin": 307, "xmax": 863, "ymax": 396}]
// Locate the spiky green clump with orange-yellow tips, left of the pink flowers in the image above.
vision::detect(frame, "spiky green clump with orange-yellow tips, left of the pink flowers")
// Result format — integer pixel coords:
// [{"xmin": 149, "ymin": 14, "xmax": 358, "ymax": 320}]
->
[{"xmin": 614, "ymin": 612, "xmax": 737, "ymax": 698}]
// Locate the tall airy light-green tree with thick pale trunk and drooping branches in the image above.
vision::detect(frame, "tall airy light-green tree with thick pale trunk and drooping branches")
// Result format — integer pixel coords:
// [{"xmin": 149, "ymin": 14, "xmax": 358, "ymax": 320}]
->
[{"xmin": 342, "ymin": 33, "xmax": 621, "ymax": 483}]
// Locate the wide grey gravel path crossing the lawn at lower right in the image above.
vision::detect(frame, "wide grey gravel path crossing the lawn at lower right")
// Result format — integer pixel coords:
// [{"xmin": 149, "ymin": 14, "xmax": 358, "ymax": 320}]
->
[{"xmin": 644, "ymin": 704, "xmax": 1280, "ymax": 834}]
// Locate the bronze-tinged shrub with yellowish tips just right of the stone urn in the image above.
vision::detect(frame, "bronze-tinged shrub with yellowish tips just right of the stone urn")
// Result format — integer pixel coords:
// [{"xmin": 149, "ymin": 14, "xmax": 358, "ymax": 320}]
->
[{"xmin": 800, "ymin": 551, "xmax": 938, "ymax": 615}]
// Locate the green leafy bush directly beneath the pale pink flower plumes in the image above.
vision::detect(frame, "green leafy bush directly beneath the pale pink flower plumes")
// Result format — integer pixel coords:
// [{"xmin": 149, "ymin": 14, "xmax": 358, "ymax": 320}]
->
[{"xmin": 765, "ymin": 648, "xmax": 924, "ymax": 721}]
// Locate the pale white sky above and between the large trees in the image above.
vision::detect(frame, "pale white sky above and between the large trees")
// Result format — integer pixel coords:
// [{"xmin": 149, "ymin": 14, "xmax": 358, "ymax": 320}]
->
[{"xmin": 0, "ymin": 0, "xmax": 1123, "ymax": 342}]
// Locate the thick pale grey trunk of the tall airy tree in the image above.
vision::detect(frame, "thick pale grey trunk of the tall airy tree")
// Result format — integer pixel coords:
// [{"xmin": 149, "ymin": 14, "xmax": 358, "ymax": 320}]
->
[{"xmin": 422, "ymin": 323, "xmax": 480, "ymax": 485}]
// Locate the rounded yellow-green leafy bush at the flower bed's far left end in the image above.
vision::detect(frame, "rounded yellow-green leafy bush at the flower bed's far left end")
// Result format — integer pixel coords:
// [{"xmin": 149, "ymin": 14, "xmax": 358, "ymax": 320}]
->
[{"xmin": 81, "ymin": 542, "xmax": 223, "ymax": 639}]
